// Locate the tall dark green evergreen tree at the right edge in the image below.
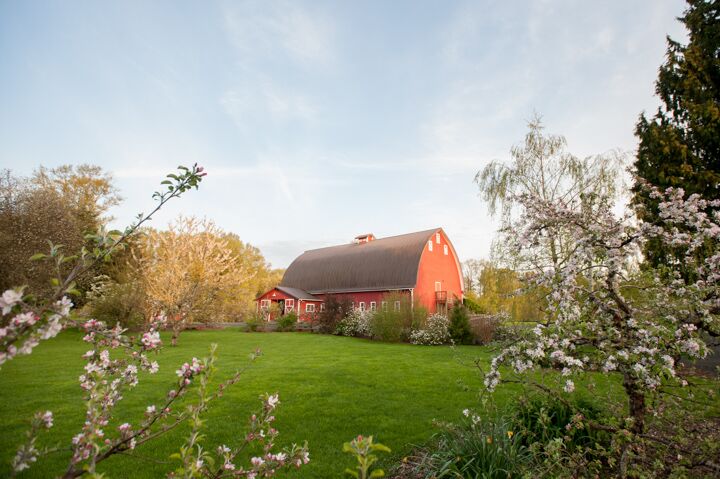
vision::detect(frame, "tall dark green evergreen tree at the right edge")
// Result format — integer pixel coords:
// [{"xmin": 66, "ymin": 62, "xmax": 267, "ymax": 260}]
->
[{"xmin": 633, "ymin": 0, "xmax": 720, "ymax": 266}]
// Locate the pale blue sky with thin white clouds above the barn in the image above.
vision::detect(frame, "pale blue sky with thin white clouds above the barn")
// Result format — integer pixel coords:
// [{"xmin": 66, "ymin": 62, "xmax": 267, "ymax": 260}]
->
[{"xmin": 0, "ymin": 0, "xmax": 685, "ymax": 267}]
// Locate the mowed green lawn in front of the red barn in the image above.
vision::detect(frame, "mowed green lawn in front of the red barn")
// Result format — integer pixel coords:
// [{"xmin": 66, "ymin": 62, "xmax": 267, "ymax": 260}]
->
[{"xmin": 0, "ymin": 330, "xmax": 524, "ymax": 478}]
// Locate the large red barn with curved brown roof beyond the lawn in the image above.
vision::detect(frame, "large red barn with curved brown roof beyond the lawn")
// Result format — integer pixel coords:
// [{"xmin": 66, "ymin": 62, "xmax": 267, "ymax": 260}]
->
[{"xmin": 257, "ymin": 228, "xmax": 463, "ymax": 320}]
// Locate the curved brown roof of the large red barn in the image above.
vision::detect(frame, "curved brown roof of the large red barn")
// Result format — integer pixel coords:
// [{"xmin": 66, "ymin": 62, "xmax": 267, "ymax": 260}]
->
[{"xmin": 280, "ymin": 228, "xmax": 440, "ymax": 294}]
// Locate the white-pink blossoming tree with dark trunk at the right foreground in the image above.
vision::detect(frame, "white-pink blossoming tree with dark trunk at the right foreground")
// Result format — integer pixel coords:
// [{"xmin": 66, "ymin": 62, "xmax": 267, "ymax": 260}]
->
[{"xmin": 485, "ymin": 189, "xmax": 720, "ymax": 472}]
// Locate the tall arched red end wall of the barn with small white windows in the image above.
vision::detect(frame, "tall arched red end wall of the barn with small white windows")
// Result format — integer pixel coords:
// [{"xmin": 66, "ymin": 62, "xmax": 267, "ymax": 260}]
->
[{"xmin": 414, "ymin": 230, "xmax": 463, "ymax": 313}]
